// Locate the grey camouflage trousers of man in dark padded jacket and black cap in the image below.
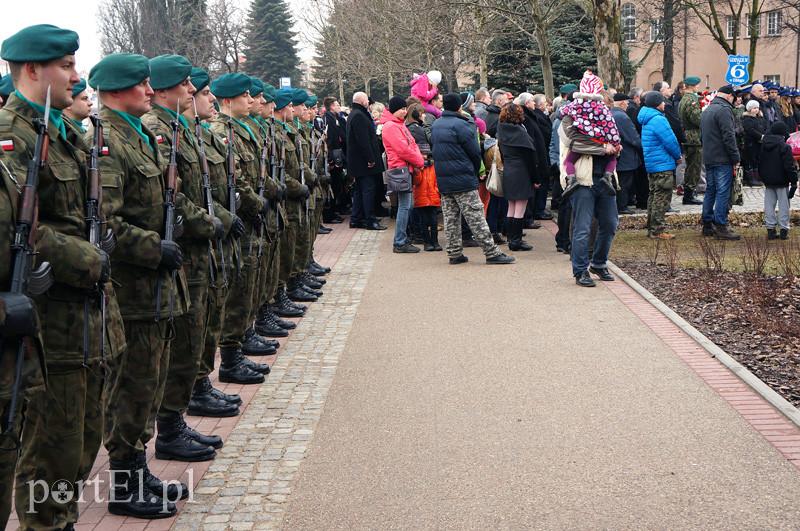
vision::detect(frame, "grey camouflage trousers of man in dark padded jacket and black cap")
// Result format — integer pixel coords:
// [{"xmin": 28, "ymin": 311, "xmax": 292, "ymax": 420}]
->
[{"xmin": 442, "ymin": 190, "xmax": 502, "ymax": 258}]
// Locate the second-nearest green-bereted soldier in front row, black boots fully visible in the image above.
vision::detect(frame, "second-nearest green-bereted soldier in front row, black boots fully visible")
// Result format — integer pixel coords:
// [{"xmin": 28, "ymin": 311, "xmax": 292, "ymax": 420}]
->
[{"xmin": 87, "ymin": 54, "xmax": 189, "ymax": 518}]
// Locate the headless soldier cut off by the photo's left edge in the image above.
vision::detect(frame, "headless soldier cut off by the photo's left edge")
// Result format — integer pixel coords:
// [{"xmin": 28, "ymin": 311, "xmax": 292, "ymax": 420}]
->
[{"xmin": 0, "ymin": 150, "xmax": 45, "ymax": 529}]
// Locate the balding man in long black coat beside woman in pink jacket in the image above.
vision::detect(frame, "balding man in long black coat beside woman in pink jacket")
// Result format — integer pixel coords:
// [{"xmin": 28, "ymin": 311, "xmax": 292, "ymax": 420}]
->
[{"xmin": 345, "ymin": 92, "xmax": 386, "ymax": 230}]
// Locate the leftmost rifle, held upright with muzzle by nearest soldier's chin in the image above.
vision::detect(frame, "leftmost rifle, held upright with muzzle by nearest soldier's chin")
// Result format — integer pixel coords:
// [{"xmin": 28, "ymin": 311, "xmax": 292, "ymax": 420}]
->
[{"xmin": 3, "ymin": 86, "xmax": 54, "ymax": 434}]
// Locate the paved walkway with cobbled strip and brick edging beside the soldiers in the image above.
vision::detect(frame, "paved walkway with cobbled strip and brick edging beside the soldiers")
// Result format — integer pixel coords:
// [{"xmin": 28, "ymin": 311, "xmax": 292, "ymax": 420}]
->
[{"xmin": 12, "ymin": 218, "xmax": 800, "ymax": 531}]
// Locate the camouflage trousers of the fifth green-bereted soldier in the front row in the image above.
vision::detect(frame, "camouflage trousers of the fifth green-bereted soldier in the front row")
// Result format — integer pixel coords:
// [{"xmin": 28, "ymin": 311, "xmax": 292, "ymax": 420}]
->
[{"xmin": 219, "ymin": 242, "xmax": 258, "ymax": 347}]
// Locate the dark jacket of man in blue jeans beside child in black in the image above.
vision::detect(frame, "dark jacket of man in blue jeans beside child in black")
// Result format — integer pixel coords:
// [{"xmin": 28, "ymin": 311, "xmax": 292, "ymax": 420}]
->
[{"xmin": 700, "ymin": 96, "xmax": 739, "ymax": 166}]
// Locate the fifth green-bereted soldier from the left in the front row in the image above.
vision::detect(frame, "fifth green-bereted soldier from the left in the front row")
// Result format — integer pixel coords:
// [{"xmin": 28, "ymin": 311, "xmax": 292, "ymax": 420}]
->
[{"xmin": 211, "ymin": 73, "xmax": 275, "ymax": 384}]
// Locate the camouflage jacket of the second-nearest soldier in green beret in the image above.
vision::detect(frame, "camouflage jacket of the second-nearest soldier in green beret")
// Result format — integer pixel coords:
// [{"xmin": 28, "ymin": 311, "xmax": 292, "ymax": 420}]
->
[{"xmin": 93, "ymin": 107, "xmax": 189, "ymax": 320}]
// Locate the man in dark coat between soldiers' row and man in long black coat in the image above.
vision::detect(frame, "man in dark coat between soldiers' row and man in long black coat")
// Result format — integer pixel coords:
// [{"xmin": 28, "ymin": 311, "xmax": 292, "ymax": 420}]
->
[{"xmin": 322, "ymin": 96, "xmax": 347, "ymax": 223}]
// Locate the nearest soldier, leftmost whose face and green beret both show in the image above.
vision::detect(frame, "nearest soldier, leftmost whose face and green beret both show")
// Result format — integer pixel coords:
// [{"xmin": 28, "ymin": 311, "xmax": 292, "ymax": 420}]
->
[{"xmin": 0, "ymin": 25, "xmax": 125, "ymax": 529}]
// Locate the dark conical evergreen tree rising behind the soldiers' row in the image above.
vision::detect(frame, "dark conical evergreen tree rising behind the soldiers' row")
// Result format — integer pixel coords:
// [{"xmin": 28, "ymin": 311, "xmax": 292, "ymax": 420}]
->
[{"xmin": 244, "ymin": 0, "xmax": 300, "ymax": 86}]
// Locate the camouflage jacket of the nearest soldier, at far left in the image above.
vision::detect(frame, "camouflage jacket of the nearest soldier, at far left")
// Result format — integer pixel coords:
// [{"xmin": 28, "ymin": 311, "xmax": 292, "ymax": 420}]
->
[{"xmin": 0, "ymin": 94, "xmax": 124, "ymax": 366}]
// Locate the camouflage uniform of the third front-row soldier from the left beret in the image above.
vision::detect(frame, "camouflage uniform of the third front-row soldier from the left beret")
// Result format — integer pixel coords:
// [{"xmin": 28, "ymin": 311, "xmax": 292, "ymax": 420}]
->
[{"xmin": 142, "ymin": 105, "xmax": 214, "ymax": 415}]
